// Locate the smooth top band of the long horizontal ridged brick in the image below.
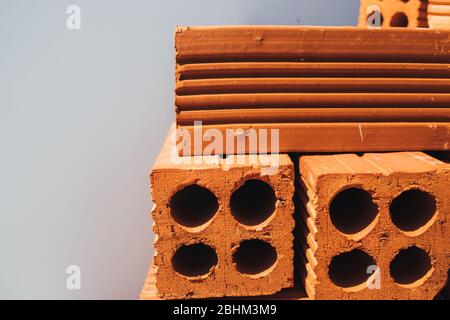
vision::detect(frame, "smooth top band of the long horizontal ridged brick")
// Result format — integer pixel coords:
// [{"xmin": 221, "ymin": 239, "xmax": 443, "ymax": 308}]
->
[{"xmin": 175, "ymin": 26, "xmax": 450, "ymax": 65}]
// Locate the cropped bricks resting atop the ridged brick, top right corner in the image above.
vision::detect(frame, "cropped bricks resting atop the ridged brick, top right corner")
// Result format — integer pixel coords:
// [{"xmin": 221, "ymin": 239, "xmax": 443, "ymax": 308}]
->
[{"xmin": 358, "ymin": 0, "xmax": 450, "ymax": 29}]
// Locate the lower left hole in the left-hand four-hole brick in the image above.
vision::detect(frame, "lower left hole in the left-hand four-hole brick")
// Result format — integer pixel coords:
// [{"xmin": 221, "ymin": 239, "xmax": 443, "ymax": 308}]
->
[{"xmin": 172, "ymin": 243, "xmax": 217, "ymax": 277}]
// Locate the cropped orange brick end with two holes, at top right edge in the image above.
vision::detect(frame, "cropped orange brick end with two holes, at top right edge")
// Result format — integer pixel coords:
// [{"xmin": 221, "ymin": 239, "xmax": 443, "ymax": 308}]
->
[{"xmin": 358, "ymin": 0, "xmax": 427, "ymax": 28}]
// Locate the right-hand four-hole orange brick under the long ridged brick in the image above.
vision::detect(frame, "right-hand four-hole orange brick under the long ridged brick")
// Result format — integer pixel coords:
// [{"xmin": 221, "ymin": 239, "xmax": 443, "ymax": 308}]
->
[{"xmin": 297, "ymin": 152, "xmax": 450, "ymax": 299}]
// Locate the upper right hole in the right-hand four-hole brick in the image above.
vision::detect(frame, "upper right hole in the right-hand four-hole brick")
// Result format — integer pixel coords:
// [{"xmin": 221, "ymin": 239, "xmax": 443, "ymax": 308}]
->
[{"xmin": 389, "ymin": 189, "xmax": 437, "ymax": 231}]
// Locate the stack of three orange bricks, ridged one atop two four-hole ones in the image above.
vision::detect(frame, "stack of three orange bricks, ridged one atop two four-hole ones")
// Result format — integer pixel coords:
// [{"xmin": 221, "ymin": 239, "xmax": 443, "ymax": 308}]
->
[{"xmin": 141, "ymin": 24, "xmax": 450, "ymax": 299}]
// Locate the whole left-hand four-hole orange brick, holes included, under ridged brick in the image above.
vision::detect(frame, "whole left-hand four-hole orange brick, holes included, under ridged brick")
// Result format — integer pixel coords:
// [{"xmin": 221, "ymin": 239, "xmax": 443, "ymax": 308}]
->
[{"xmin": 151, "ymin": 127, "xmax": 294, "ymax": 299}]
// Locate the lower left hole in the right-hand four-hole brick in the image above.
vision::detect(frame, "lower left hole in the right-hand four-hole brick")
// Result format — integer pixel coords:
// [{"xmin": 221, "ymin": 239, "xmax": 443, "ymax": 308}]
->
[{"xmin": 328, "ymin": 249, "xmax": 376, "ymax": 288}]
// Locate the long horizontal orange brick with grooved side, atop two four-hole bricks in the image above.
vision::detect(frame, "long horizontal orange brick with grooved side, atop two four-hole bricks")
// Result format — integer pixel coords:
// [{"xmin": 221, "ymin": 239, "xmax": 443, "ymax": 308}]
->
[{"xmin": 175, "ymin": 26, "xmax": 450, "ymax": 155}]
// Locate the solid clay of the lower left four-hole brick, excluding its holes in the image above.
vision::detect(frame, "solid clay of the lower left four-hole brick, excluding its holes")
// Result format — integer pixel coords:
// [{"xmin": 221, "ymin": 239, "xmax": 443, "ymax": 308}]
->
[{"xmin": 150, "ymin": 126, "xmax": 294, "ymax": 299}]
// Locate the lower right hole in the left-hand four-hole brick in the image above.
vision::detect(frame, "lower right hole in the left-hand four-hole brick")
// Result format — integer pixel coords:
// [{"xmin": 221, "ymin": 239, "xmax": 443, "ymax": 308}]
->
[{"xmin": 233, "ymin": 239, "xmax": 278, "ymax": 275}]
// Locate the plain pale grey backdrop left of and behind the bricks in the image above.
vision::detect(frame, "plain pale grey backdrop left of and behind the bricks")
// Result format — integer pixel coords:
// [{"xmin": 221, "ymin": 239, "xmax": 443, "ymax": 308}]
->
[{"xmin": 0, "ymin": 0, "xmax": 359, "ymax": 299}]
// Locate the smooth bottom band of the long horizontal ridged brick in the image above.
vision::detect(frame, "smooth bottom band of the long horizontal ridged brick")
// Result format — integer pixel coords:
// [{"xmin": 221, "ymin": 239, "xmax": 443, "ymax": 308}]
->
[{"xmin": 178, "ymin": 121, "xmax": 450, "ymax": 155}]
